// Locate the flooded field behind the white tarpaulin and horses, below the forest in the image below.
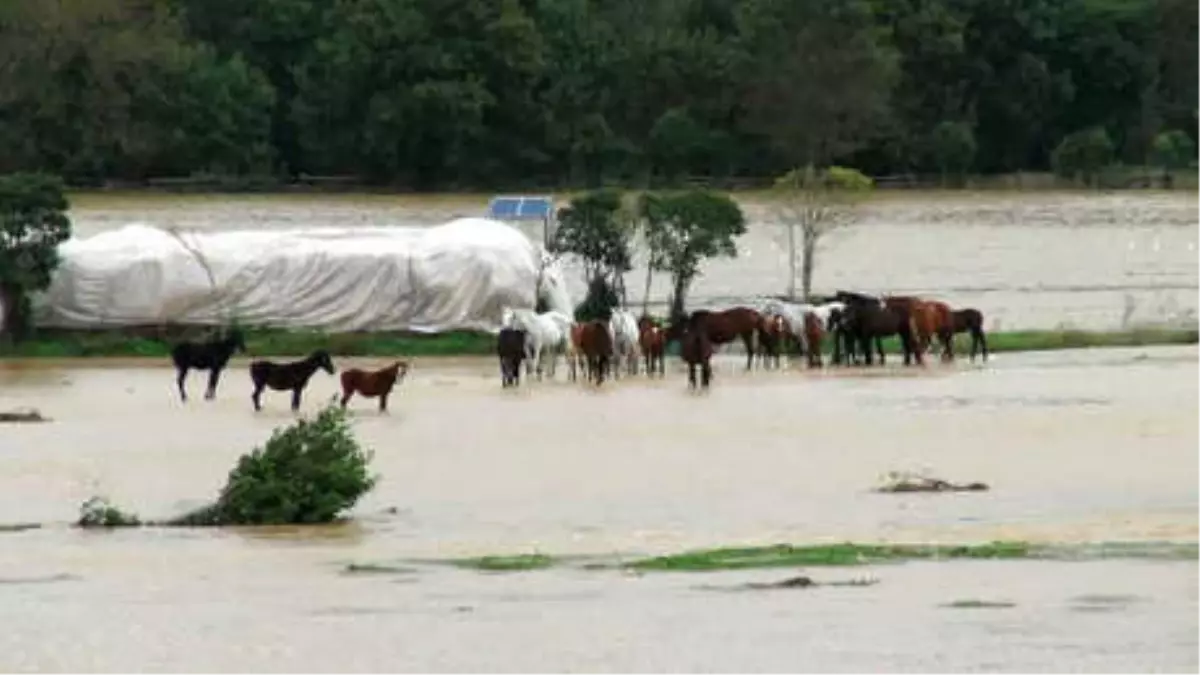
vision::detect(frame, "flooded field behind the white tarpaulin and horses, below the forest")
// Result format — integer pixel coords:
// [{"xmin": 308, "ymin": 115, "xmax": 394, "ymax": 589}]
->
[{"xmin": 72, "ymin": 192, "xmax": 1200, "ymax": 330}]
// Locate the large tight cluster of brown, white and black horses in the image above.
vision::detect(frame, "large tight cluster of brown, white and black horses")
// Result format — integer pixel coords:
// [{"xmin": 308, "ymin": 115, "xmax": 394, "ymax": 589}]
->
[{"xmin": 496, "ymin": 291, "xmax": 988, "ymax": 388}]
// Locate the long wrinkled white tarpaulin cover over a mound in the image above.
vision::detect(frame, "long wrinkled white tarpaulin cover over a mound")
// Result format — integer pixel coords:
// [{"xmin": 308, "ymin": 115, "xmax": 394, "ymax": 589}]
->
[{"xmin": 36, "ymin": 217, "xmax": 571, "ymax": 333}]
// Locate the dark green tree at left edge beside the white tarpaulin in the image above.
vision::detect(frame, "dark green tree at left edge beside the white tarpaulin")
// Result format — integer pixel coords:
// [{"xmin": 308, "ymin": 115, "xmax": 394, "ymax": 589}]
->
[{"xmin": 0, "ymin": 173, "xmax": 71, "ymax": 341}]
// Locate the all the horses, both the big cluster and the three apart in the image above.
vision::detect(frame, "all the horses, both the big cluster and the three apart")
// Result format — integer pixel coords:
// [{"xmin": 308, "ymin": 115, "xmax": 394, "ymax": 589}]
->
[{"xmin": 170, "ymin": 291, "xmax": 988, "ymax": 403}]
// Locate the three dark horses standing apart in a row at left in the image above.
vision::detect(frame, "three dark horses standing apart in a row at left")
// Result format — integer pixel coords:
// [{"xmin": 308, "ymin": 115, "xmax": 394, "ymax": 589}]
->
[{"xmin": 170, "ymin": 328, "xmax": 409, "ymax": 412}]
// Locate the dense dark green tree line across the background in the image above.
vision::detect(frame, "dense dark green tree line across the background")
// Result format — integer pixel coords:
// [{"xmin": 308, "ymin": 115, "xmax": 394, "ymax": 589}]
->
[{"xmin": 0, "ymin": 0, "xmax": 1200, "ymax": 189}]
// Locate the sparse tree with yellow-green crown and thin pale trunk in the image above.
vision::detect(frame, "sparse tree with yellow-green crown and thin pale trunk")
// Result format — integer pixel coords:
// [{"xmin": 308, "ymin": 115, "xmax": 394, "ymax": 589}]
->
[{"xmin": 774, "ymin": 165, "xmax": 874, "ymax": 301}]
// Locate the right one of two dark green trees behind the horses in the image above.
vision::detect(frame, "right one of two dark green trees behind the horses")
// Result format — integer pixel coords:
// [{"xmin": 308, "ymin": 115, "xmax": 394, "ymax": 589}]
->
[{"xmin": 638, "ymin": 190, "xmax": 746, "ymax": 317}]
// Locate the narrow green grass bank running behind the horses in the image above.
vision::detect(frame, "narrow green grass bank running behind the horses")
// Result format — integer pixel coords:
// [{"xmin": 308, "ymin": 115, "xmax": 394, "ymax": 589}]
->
[{"xmin": 0, "ymin": 328, "xmax": 1200, "ymax": 358}]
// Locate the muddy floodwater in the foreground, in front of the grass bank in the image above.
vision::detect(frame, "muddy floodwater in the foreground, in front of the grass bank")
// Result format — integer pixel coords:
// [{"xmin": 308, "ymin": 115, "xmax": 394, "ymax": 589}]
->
[{"xmin": 0, "ymin": 348, "xmax": 1200, "ymax": 675}]
